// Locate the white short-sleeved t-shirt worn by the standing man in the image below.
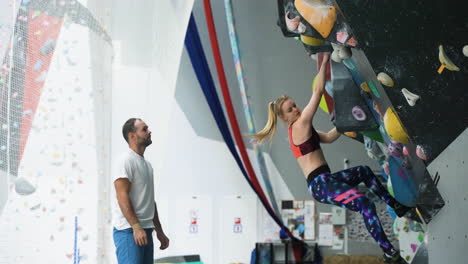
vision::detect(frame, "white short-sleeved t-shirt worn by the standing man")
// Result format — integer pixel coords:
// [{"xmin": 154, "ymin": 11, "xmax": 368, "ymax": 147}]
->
[{"xmin": 111, "ymin": 148, "xmax": 155, "ymax": 230}]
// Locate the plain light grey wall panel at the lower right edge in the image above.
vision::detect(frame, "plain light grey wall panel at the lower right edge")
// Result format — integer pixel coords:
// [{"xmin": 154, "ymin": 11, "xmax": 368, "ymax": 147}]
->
[{"xmin": 427, "ymin": 129, "xmax": 468, "ymax": 264}]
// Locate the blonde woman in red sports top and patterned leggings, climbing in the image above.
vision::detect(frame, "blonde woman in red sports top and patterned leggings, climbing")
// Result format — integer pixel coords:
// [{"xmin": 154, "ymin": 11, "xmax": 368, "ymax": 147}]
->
[{"xmin": 251, "ymin": 53, "xmax": 411, "ymax": 263}]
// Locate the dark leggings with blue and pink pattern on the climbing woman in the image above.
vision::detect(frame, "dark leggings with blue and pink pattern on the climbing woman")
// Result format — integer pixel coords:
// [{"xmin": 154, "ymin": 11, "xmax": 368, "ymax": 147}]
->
[{"xmin": 309, "ymin": 166, "xmax": 396, "ymax": 255}]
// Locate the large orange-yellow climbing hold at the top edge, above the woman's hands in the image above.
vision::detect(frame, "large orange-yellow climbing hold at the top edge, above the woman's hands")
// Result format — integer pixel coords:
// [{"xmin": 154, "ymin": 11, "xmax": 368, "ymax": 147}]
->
[{"xmin": 294, "ymin": 0, "xmax": 336, "ymax": 38}]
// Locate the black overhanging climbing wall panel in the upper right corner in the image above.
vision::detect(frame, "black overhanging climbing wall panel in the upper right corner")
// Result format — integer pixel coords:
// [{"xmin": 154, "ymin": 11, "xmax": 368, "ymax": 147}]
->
[{"xmin": 336, "ymin": 0, "xmax": 468, "ymax": 163}]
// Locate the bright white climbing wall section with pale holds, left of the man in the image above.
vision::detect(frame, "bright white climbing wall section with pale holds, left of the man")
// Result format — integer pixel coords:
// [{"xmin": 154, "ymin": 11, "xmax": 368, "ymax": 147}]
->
[{"xmin": 0, "ymin": 21, "xmax": 99, "ymax": 264}]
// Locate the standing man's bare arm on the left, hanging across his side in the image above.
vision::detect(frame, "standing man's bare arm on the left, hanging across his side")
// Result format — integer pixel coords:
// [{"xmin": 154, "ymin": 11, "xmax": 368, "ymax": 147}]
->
[{"xmin": 114, "ymin": 178, "xmax": 148, "ymax": 246}]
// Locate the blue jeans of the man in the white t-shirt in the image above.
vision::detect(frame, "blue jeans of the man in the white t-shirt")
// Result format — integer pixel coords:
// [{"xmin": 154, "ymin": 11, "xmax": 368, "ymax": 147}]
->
[{"xmin": 114, "ymin": 228, "xmax": 153, "ymax": 264}]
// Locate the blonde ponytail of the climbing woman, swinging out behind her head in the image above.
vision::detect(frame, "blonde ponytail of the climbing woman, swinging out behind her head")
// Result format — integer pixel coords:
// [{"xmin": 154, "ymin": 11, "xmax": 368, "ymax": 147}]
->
[{"xmin": 249, "ymin": 95, "xmax": 289, "ymax": 144}]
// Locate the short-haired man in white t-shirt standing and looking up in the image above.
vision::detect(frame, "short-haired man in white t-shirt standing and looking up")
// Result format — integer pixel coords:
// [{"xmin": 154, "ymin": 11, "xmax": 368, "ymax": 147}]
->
[{"xmin": 112, "ymin": 118, "xmax": 169, "ymax": 264}]
